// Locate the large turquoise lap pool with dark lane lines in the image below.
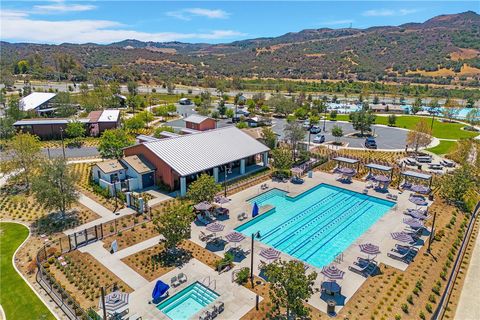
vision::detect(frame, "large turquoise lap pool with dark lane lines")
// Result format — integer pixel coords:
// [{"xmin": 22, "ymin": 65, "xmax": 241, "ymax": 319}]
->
[{"xmin": 236, "ymin": 184, "xmax": 395, "ymax": 268}]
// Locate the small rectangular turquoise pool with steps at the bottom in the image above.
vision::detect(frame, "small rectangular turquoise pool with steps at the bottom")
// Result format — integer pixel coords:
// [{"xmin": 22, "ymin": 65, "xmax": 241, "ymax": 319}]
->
[{"xmin": 157, "ymin": 281, "xmax": 219, "ymax": 320}]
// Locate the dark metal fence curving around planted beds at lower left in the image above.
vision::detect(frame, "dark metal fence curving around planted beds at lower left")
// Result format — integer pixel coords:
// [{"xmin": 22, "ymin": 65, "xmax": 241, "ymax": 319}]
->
[{"xmin": 36, "ymin": 211, "xmax": 151, "ymax": 320}]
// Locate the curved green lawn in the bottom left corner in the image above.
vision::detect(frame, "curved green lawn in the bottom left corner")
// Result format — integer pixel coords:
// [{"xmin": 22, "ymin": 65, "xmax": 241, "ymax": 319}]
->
[{"xmin": 0, "ymin": 222, "xmax": 55, "ymax": 320}]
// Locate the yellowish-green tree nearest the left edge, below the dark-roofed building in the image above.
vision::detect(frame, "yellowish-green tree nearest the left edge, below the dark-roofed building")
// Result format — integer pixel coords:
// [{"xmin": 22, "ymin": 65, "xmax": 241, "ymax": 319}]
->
[{"xmin": 6, "ymin": 133, "xmax": 41, "ymax": 188}]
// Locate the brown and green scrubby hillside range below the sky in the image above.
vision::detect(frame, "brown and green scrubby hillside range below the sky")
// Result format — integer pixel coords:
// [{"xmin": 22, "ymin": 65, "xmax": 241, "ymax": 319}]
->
[{"xmin": 0, "ymin": 11, "xmax": 480, "ymax": 84}]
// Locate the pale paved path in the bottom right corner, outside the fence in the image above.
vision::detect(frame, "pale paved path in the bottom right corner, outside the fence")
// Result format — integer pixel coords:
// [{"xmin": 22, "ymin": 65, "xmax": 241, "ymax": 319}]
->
[{"xmin": 455, "ymin": 228, "xmax": 480, "ymax": 320}]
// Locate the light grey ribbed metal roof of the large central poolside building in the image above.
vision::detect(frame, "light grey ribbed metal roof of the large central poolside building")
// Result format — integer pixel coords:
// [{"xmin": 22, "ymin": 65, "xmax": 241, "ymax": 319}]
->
[{"xmin": 144, "ymin": 126, "xmax": 270, "ymax": 176}]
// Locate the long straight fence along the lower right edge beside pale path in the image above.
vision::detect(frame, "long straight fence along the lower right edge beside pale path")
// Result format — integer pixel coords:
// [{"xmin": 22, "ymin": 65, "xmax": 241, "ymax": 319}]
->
[{"xmin": 432, "ymin": 202, "xmax": 480, "ymax": 320}]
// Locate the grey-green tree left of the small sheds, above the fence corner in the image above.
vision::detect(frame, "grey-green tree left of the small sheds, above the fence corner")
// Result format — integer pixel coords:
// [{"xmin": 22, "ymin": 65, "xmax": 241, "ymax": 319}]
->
[{"xmin": 32, "ymin": 157, "xmax": 79, "ymax": 215}]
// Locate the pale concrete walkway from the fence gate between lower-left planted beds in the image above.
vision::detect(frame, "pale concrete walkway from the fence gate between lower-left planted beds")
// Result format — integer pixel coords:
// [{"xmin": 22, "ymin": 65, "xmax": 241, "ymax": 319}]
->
[{"xmin": 79, "ymin": 240, "xmax": 148, "ymax": 290}]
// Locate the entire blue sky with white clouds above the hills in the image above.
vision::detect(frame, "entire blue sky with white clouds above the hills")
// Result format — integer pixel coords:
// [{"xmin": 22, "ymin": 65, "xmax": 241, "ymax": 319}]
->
[{"xmin": 0, "ymin": 0, "xmax": 480, "ymax": 44}]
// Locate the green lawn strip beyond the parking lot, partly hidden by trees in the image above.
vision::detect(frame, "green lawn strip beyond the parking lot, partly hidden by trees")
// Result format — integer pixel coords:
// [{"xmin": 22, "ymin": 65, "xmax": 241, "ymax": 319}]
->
[{"xmin": 326, "ymin": 114, "xmax": 478, "ymax": 139}]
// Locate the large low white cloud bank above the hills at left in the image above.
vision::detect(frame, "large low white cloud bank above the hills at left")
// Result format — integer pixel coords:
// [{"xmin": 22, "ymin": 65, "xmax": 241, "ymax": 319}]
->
[{"xmin": 0, "ymin": 10, "xmax": 245, "ymax": 44}]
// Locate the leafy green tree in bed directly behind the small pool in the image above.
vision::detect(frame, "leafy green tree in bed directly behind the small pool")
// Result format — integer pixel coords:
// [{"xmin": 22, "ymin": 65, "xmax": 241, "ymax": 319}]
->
[{"xmin": 154, "ymin": 203, "xmax": 193, "ymax": 252}]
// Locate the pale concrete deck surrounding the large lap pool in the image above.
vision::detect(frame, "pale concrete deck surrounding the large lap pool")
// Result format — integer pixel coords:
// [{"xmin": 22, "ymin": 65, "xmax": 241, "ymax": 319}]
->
[{"xmin": 188, "ymin": 172, "xmax": 427, "ymax": 312}]
